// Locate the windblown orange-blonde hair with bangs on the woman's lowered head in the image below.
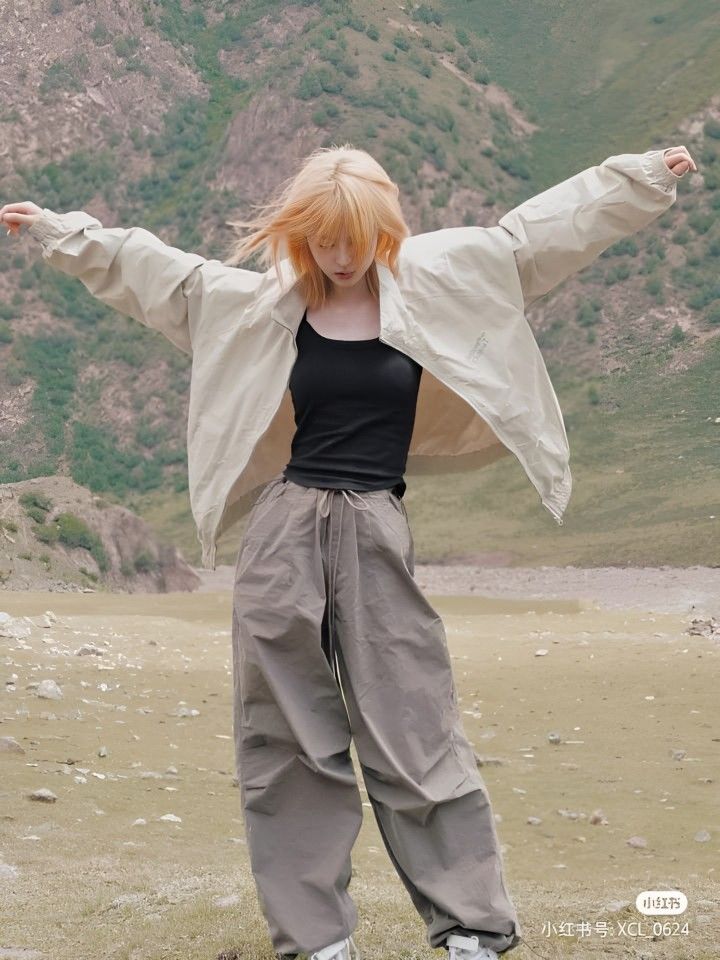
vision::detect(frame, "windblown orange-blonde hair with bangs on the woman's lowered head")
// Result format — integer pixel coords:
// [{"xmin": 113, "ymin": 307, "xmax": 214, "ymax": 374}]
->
[{"xmin": 223, "ymin": 143, "xmax": 410, "ymax": 309}]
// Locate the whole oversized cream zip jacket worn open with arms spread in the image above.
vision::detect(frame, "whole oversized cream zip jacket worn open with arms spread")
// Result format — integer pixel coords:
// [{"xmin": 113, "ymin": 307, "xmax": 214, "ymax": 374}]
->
[{"xmin": 29, "ymin": 148, "xmax": 680, "ymax": 570}]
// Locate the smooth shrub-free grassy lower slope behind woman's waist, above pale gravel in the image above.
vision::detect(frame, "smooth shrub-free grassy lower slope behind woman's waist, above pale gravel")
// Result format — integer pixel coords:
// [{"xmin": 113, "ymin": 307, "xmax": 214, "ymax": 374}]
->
[{"xmin": 133, "ymin": 338, "xmax": 720, "ymax": 567}]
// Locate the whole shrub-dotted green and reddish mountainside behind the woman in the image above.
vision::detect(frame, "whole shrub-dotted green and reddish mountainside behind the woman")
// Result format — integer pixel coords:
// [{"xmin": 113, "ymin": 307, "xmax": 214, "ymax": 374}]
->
[{"xmin": 0, "ymin": 0, "xmax": 720, "ymax": 565}]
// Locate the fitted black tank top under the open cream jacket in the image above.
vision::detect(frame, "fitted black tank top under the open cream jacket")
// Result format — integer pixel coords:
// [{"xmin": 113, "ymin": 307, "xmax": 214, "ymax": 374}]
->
[{"xmin": 283, "ymin": 312, "xmax": 423, "ymax": 497}]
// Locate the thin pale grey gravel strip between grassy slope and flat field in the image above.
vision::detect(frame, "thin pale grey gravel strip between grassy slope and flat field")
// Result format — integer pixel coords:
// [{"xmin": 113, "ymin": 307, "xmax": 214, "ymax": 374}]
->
[{"xmin": 194, "ymin": 564, "xmax": 720, "ymax": 617}]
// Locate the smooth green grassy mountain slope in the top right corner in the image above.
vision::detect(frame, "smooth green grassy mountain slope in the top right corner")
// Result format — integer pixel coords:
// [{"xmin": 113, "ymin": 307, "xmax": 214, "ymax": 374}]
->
[{"xmin": 440, "ymin": 0, "xmax": 720, "ymax": 189}]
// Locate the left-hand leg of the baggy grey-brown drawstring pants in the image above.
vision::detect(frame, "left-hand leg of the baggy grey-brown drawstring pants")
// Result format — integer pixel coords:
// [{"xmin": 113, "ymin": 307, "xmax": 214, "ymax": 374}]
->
[{"xmin": 232, "ymin": 479, "xmax": 362, "ymax": 954}]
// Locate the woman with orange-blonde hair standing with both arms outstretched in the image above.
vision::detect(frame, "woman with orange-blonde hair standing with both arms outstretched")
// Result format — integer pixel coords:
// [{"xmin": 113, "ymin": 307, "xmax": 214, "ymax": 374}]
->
[{"xmin": 0, "ymin": 146, "xmax": 695, "ymax": 960}]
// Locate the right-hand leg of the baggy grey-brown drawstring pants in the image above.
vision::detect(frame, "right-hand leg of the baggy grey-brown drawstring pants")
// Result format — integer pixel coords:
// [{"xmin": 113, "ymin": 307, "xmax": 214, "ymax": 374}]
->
[{"xmin": 335, "ymin": 491, "xmax": 521, "ymax": 953}]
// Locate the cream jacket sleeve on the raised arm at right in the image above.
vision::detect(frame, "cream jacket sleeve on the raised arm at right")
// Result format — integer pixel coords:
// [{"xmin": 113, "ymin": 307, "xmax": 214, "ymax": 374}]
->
[{"xmin": 498, "ymin": 147, "xmax": 681, "ymax": 307}]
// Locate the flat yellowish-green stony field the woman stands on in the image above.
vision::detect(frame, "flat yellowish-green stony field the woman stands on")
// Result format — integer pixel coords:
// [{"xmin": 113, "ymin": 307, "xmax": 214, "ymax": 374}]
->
[{"xmin": 0, "ymin": 593, "xmax": 720, "ymax": 960}]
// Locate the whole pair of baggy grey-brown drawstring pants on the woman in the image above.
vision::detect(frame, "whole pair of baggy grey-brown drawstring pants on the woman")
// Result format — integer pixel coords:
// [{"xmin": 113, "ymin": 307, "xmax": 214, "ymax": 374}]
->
[{"xmin": 232, "ymin": 474, "xmax": 522, "ymax": 954}]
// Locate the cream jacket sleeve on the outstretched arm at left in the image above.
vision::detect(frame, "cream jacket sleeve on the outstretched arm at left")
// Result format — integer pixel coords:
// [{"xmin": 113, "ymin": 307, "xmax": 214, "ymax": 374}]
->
[{"xmin": 28, "ymin": 208, "xmax": 216, "ymax": 354}]
